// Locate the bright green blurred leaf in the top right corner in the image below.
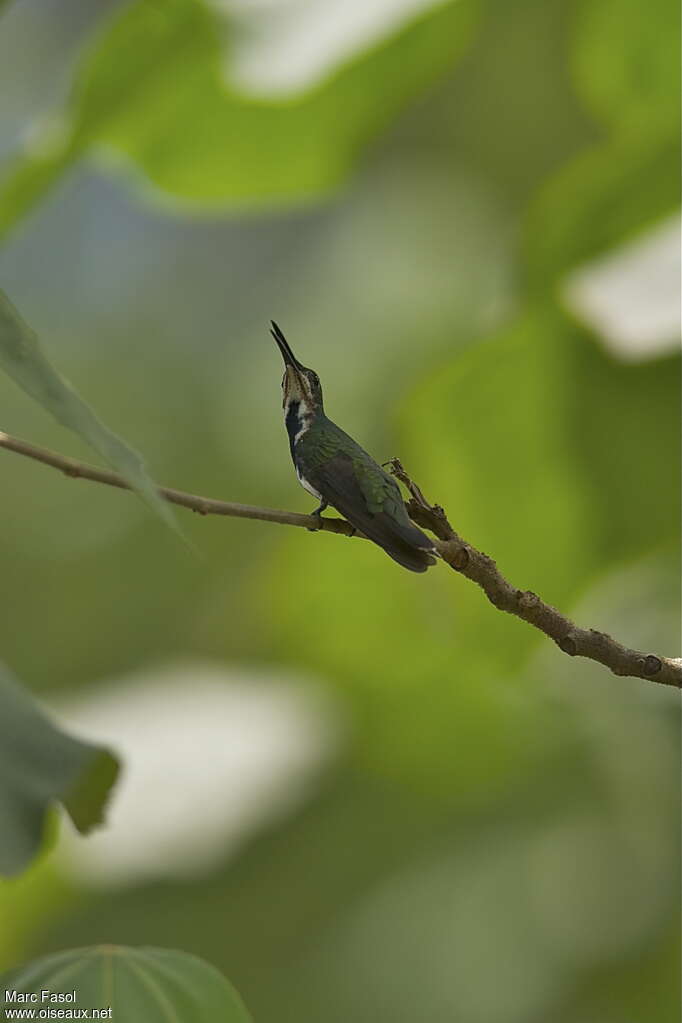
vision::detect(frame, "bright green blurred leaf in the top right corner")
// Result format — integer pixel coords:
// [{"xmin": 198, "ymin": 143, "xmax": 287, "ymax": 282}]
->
[{"xmin": 574, "ymin": 0, "xmax": 680, "ymax": 132}]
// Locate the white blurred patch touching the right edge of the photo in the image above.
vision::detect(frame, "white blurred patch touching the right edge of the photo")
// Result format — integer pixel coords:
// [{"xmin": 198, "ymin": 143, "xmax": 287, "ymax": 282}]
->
[{"xmin": 563, "ymin": 216, "xmax": 681, "ymax": 360}]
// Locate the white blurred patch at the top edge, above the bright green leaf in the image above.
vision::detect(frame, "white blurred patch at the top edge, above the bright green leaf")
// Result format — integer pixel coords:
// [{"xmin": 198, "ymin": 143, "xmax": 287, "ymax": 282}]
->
[{"xmin": 213, "ymin": 0, "xmax": 442, "ymax": 97}]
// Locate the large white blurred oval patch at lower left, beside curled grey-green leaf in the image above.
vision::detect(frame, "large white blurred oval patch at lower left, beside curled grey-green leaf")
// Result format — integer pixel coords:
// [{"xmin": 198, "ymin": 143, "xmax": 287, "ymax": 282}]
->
[{"xmin": 52, "ymin": 663, "xmax": 340, "ymax": 885}]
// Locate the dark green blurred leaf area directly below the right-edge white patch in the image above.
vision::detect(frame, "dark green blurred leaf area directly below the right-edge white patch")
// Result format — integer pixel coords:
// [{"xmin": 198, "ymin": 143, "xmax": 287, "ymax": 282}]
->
[{"xmin": 564, "ymin": 337, "xmax": 682, "ymax": 571}]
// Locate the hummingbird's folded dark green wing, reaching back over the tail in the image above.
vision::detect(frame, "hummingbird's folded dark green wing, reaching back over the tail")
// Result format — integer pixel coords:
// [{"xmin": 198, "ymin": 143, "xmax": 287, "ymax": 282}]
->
[{"xmin": 310, "ymin": 452, "xmax": 436, "ymax": 572}]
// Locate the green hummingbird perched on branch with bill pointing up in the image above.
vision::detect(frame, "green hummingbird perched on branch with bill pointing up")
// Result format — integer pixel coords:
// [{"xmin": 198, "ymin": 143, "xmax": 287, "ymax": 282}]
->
[{"xmin": 270, "ymin": 320, "xmax": 436, "ymax": 572}]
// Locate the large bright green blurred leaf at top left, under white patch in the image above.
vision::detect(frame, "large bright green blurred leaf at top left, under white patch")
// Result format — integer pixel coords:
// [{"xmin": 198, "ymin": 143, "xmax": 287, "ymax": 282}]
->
[{"xmin": 0, "ymin": 0, "xmax": 474, "ymax": 233}]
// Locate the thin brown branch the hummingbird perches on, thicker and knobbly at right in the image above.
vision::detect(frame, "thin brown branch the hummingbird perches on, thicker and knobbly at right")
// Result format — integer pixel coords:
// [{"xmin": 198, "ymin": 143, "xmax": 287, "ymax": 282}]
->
[{"xmin": 0, "ymin": 432, "xmax": 682, "ymax": 688}]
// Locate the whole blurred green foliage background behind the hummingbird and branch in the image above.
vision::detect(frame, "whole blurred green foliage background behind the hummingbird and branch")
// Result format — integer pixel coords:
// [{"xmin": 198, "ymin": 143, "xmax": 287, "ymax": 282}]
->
[{"xmin": 0, "ymin": 0, "xmax": 680, "ymax": 1023}]
